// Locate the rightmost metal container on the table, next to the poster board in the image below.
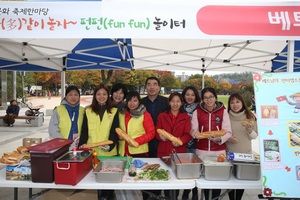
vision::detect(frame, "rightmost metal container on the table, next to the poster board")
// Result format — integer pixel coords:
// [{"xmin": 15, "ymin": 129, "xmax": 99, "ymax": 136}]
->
[{"xmin": 231, "ymin": 162, "xmax": 261, "ymax": 180}]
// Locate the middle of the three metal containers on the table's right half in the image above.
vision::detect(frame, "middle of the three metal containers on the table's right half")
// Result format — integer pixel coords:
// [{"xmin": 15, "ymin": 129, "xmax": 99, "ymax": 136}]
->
[{"xmin": 202, "ymin": 156, "xmax": 233, "ymax": 181}]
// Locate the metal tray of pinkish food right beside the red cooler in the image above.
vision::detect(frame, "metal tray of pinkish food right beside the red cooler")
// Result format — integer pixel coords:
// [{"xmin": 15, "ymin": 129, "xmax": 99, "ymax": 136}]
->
[{"xmin": 94, "ymin": 160, "xmax": 126, "ymax": 183}]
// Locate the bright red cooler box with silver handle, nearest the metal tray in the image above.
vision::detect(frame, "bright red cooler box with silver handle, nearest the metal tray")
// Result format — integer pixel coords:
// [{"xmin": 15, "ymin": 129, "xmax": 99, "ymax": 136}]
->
[{"xmin": 54, "ymin": 150, "xmax": 92, "ymax": 185}]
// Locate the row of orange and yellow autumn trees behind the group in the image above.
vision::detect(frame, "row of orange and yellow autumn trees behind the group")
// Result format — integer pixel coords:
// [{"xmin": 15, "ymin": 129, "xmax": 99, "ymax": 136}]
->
[{"xmin": 3, "ymin": 70, "xmax": 253, "ymax": 101}]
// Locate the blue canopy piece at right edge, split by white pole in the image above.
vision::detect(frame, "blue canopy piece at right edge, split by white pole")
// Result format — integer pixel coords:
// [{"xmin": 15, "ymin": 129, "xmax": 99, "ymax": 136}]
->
[{"xmin": 272, "ymin": 41, "xmax": 300, "ymax": 72}]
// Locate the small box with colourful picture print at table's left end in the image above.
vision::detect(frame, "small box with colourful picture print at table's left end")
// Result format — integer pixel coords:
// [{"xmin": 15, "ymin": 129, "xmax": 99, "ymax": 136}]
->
[{"xmin": 6, "ymin": 165, "xmax": 31, "ymax": 181}]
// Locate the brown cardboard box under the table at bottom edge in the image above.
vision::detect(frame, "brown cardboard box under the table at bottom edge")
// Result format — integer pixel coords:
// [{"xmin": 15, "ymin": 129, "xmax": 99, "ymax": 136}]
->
[{"xmin": 41, "ymin": 189, "xmax": 98, "ymax": 200}]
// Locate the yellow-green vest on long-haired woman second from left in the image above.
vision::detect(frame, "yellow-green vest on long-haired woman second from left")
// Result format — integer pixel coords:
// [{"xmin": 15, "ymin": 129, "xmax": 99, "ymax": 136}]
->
[{"xmin": 86, "ymin": 108, "xmax": 118, "ymax": 156}]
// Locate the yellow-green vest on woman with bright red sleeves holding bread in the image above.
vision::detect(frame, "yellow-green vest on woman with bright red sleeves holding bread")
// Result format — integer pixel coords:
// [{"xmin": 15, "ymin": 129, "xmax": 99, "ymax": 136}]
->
[{"xmin": 119, "ymin": 113, "xmax": 149, "ymax": 156}]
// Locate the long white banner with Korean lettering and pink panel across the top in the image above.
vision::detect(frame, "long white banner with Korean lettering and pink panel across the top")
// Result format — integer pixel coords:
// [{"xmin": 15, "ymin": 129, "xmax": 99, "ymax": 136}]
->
[{"xmin": 0, "ymin": 0, "xmax": 300, "ymax": 40}]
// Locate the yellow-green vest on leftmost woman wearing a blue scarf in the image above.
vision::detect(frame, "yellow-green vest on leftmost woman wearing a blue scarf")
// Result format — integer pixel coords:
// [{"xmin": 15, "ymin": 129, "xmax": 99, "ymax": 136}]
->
[{"xmin": 56, "ymin": 105, "xmax": 84, "ymax": 139}]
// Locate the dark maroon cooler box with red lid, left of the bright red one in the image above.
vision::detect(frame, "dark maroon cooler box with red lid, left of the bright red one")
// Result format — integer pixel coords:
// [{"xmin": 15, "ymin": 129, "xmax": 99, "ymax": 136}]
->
[{"xmin": 28, "ymin": 138, "xmax": 73, "ymax": 183}]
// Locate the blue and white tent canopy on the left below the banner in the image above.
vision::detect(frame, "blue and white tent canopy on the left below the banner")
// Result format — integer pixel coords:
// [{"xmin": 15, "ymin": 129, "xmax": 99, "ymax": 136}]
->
[{"xmin": 0, "ymin": 39, "xmax": 133, "ymax": 72}]
